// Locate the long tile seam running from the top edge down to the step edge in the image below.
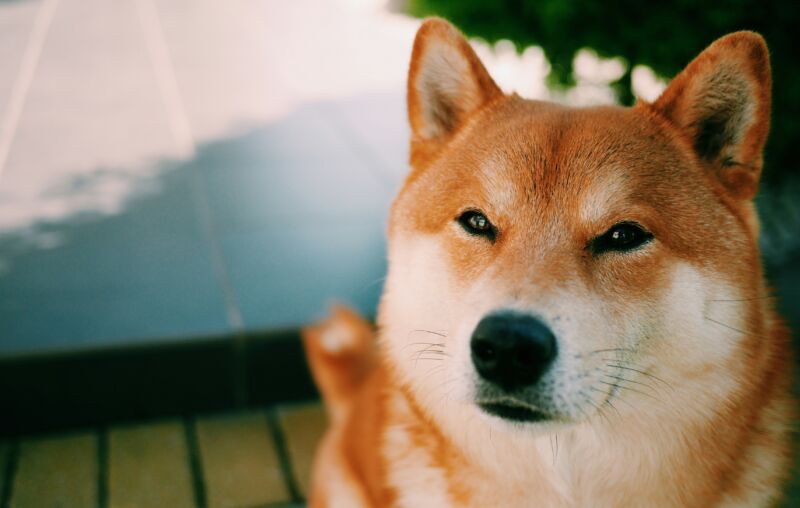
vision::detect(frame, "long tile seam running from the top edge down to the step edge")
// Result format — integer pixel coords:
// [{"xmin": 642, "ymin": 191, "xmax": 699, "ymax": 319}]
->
[{"xmin": 136, "ymin": 0, "xmax": 244, "ymax": 332}]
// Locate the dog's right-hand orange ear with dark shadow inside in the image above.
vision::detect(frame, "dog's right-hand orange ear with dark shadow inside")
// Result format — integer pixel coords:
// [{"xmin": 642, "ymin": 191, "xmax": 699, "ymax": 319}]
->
[{"xmin": 653, "ymin": 32, "xmax": 771, "ymax": 199}]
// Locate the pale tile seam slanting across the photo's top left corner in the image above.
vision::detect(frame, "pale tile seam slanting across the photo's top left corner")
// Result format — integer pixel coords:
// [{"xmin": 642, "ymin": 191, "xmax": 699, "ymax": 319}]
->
[{"xmin": 0, "ymin": 0, "xmax": 60, "ymax": 180}]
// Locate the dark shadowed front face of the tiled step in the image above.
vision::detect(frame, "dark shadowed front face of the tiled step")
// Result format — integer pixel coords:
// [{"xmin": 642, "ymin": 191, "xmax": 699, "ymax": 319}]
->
[{"xmin": 0, "ymin": 330, "xmax": 318, "ymax": 436}]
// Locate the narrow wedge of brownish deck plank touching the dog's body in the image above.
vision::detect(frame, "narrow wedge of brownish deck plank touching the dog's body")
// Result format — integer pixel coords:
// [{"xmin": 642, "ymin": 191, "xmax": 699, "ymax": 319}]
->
[{"xmin": 278, "ymin": 404, "xmax": 327, "ymax": 497}]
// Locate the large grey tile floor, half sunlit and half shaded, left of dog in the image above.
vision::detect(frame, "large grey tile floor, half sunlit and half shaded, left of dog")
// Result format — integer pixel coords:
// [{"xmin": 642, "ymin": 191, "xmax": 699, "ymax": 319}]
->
[{"xmin": 0, "ymin": 0, "xmax": 413, "ymax": 354}]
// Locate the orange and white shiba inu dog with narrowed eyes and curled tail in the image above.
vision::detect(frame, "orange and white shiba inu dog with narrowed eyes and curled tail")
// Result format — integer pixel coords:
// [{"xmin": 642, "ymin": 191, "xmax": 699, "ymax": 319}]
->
[{"xmin": 304, "ymin": 19, "xmax": 793, "ymax": 508}]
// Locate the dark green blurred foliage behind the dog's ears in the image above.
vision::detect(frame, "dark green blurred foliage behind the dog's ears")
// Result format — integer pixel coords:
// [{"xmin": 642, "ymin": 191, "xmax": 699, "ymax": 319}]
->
[{"xmin": 408, "ymin": 0, "xmax": 800, "ymax": 183}]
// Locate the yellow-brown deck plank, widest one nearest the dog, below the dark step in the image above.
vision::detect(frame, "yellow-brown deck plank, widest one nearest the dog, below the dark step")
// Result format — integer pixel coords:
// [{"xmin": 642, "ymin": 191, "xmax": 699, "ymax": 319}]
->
[{"xmin": 196, "ymin": 412, "xmax": 290, "ymax": 508}]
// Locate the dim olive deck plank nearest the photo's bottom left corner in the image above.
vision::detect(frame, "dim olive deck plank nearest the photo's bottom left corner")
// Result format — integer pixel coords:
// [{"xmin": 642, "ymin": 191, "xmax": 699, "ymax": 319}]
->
[{"xmin": 10, "ymin": 433, "xmax": 98, "ymax": 508}]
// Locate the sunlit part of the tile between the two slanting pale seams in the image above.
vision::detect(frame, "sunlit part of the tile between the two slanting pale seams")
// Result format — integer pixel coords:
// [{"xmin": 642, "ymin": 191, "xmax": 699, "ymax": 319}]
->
[{"xmin": 3, "ymin": 0, "xmax": 180, "ymax": 192}]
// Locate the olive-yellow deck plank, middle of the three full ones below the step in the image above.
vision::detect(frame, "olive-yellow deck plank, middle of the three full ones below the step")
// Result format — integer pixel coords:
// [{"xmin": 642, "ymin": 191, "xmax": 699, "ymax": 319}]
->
[{"xmin": 108, "ymin": 421, "xmax": 195, "ymax": 508}]
